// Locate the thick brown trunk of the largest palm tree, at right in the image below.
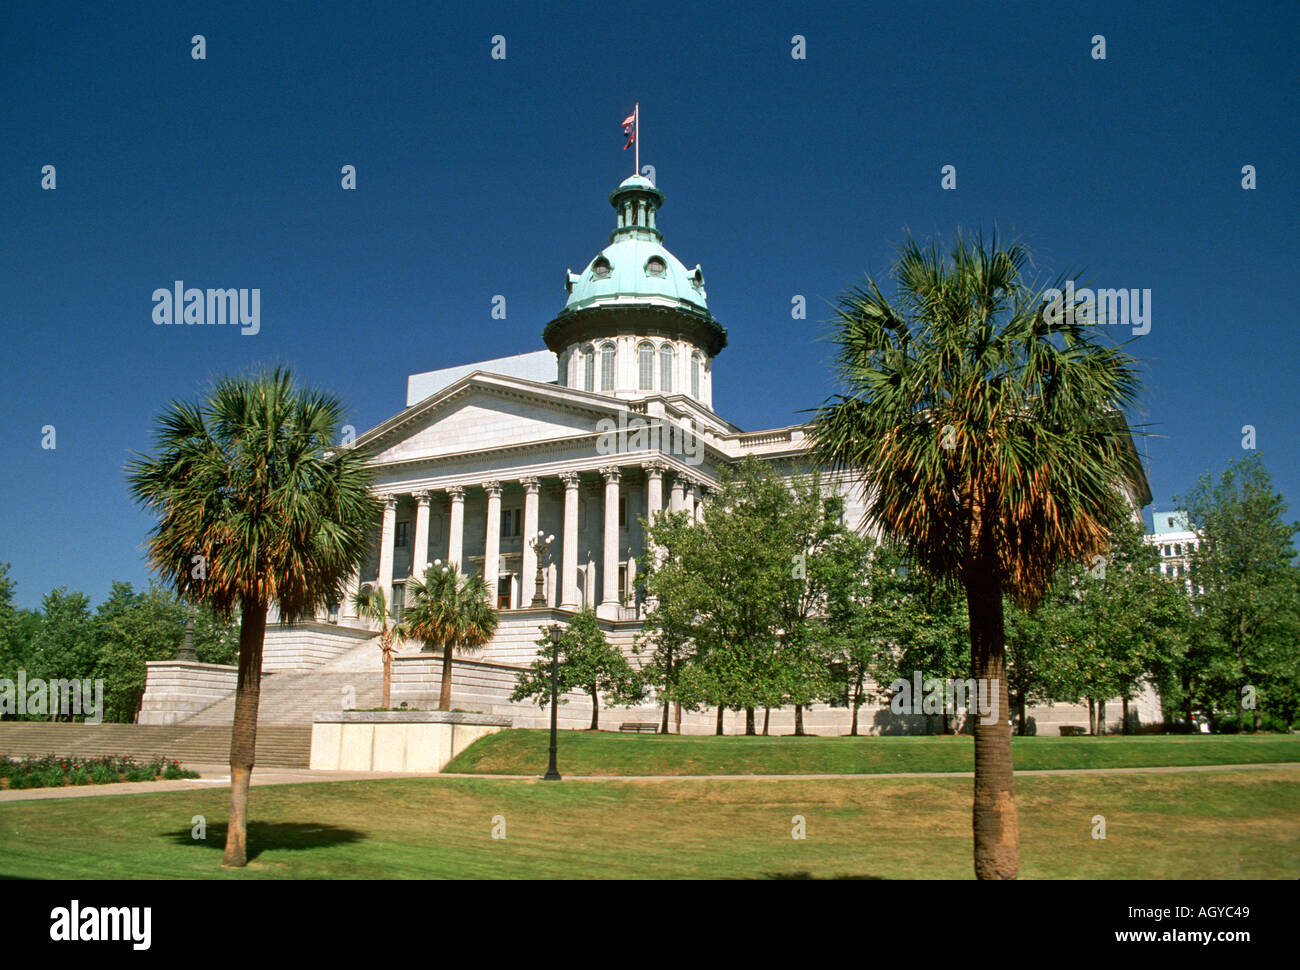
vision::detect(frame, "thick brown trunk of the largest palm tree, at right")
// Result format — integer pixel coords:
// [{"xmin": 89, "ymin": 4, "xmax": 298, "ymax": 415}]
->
[{"xmin": 965, "ymin": 563, "xmax": 1021, "ymax": 879}]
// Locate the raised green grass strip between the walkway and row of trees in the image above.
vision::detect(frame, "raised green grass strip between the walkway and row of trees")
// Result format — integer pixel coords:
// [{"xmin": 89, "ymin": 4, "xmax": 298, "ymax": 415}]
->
[{"xmin": 446, "ymin": 729, "xmax": 1300, "ymax": 775}]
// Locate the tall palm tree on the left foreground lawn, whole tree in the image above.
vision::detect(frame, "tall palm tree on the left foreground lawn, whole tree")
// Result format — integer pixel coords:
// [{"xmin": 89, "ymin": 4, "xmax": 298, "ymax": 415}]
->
[{"xmin": 126, "ymin": 368, "xmax": 378, "ymax": 866}]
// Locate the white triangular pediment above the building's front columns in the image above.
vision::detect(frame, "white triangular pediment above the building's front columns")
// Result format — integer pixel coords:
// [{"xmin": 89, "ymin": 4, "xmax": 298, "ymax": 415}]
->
[{"xmin": 356, "ymin": 372, "xmax": 623, "ymax": 464}]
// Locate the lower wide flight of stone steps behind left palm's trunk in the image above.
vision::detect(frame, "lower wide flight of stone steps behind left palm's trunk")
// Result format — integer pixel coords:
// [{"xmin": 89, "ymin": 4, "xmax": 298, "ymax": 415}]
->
[{"xmin": 0, "ymin": 722, "xmax": 312, "ymax": 768}]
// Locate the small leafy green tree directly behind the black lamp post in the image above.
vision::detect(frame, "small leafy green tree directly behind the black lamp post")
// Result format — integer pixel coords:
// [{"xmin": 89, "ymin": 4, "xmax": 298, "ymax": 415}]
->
[{"xmin": 510, "ymin": 610, "xmax": 645, "ymax": 731}]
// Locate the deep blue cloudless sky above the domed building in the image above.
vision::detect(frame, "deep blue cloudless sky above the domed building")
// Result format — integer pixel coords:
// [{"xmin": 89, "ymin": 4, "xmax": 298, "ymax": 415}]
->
[{"xmin": 0, "ymin": 0, "xmax": 1300, "ymax": 606}]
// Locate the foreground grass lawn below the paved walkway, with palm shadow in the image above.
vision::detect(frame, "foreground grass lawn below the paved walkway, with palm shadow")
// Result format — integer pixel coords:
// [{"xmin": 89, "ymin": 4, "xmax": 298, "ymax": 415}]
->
[{"xmin": 0, "ymin": 766, "xmax": 1300, "ymax": 879}]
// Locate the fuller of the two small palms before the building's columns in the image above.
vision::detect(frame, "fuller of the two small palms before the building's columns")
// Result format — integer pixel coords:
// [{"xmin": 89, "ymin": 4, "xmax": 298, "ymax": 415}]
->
[{"xmin": 403, "ymin": 560, "xmax": 498, "ymax": 711}]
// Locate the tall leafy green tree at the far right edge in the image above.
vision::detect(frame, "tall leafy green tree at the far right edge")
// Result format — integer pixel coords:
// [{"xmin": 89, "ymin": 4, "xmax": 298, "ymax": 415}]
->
[{"xmin": 1179, "ymin": 452, "xmax": 1300, "ymax": 729}]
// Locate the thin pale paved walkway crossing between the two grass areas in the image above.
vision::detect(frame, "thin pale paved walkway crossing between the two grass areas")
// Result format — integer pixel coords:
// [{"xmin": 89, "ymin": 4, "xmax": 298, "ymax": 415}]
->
[{"xmin": 0, "ymin": 762, "xmax": 1300, "ymax": 804}]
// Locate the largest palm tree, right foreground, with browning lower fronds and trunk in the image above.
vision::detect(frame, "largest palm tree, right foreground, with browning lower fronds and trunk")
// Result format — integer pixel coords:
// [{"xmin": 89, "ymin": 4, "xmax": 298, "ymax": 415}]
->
[{"xmin": 813, "ymin": 234, "xmax": 1141, "ymax": 879}]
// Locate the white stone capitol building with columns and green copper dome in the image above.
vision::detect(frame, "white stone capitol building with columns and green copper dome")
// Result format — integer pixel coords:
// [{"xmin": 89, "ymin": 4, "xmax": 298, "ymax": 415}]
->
[{"xmin": 140, "ymin": 176, "xmax": 1160, "ymax": 733}]
